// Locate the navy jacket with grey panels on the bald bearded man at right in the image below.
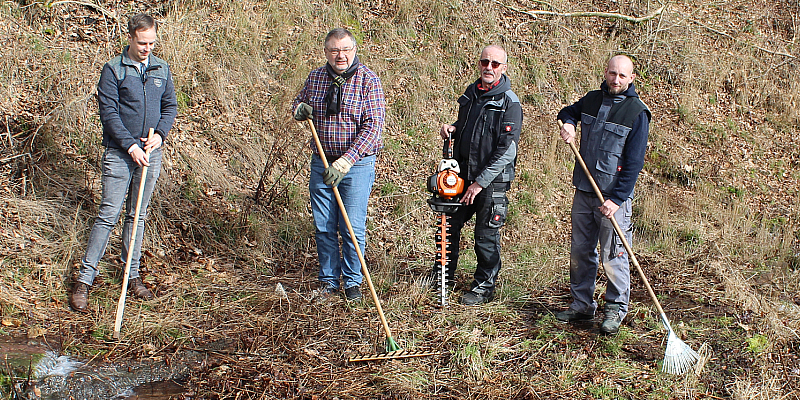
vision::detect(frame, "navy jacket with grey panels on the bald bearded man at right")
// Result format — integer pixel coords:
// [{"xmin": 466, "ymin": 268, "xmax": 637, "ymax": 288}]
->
[{"xmin": 558, "ymin": 82, "xmax": 651, "ymax": 205}]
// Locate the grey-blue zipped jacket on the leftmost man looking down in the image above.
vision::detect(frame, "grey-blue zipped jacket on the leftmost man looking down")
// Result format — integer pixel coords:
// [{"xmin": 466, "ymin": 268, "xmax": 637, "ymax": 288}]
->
[{"xmin": 97, "ymin": 46, "xmax": 178, "ymax": 151}]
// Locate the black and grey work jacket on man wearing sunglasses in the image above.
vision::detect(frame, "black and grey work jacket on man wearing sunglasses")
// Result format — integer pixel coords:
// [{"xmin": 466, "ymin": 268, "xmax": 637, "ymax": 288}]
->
[{"xmin": 453, "ymin": 75, "xmax": 522, "ymax": 189}]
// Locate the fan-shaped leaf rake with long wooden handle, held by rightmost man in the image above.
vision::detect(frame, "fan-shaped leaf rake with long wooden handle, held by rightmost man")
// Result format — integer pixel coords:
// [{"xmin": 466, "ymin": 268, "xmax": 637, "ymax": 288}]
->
[{"xmin": 558, "ymin": 121, "xmax": 700, "ymax": 375}]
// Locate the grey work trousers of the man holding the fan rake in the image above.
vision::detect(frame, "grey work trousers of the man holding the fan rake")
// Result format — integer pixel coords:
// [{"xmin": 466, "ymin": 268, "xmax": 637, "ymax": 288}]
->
[{"xmin": 569, "ymin": 190, "xmax": 633, "ymax": 318}]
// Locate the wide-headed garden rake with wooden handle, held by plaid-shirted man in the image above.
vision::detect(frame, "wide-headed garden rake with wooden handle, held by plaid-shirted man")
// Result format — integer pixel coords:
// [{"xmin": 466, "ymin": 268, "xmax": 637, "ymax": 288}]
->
[{"xmin": 308, "ymin": 118, "xmax": 439, "ymax": 362}]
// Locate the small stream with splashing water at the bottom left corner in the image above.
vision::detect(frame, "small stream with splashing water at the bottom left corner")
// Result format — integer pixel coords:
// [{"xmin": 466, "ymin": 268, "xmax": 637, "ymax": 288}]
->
[{"xmin": 0, "ymin": 337, "xmax": 200, "ymax": 400}]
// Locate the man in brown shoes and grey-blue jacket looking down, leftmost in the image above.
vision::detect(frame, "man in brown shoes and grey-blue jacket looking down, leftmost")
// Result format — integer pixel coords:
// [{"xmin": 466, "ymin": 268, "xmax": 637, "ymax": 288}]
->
[{"xmin": 69, "ymin": 14, "xmax": 178, "ymax": 312}]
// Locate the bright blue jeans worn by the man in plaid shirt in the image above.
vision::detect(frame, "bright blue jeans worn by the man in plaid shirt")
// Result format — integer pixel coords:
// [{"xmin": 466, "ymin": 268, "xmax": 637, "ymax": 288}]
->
[{"xmin": 308, "ymin": 154, "xmax": 375, "ymax": 289}]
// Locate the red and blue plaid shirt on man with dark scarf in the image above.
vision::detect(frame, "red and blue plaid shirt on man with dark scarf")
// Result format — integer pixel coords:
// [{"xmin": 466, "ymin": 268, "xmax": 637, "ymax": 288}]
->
[{"xmin": 292, "ymin": 64, "xmax": 386, "ymax": 164}]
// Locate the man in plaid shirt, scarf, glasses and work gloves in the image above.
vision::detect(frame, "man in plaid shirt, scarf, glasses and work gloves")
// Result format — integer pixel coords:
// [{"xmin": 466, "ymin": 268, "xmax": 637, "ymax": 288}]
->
[{"xmin": 292, "ymin": 28, "xmax": 386, "ymax": 300}]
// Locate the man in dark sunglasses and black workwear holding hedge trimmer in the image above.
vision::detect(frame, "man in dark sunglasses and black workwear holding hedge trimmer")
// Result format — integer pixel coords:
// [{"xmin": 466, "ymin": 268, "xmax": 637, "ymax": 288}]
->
[{"xmin": 434, "ymin": 45, "xmax": 522, "ymax": 305}]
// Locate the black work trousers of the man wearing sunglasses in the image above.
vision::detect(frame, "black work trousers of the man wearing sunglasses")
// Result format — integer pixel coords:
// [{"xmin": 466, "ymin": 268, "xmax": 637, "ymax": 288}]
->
[{"xmin": 438, "ymin": 183, "xmax": 509, "ymax": 295}]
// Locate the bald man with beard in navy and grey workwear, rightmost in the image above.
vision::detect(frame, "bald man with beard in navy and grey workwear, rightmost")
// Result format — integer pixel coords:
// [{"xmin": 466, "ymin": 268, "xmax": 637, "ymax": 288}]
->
[{"xmin": 556, "ymin": 55, "xmax": 651, "ymax": 334}]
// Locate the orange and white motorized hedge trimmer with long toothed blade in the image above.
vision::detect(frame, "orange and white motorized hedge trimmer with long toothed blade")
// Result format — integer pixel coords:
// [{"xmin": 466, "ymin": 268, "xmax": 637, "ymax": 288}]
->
[{"xmin": 428, "ymin": 135, "xmax": 464, "ymax": 307}]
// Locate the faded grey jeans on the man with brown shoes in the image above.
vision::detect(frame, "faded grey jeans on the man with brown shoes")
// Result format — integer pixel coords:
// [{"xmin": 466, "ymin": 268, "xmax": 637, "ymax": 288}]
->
[{"xmin": 78, "ymin": 147, "xmax": 162, "ymax": 286}]
